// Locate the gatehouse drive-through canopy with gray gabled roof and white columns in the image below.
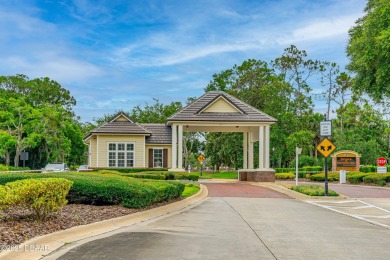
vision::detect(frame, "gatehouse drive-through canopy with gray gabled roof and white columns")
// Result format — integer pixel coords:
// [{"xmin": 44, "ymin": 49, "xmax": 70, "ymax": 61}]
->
[{"xmin": 167, "ymin": 91, "xmax": 276, "ymax": 171}]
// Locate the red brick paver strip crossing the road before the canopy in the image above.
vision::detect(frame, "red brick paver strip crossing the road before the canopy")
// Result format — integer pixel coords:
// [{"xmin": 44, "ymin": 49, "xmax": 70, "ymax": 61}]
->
[{"xmin": 203, "ymin": 183, "xmax": 290, "ymax": 199}]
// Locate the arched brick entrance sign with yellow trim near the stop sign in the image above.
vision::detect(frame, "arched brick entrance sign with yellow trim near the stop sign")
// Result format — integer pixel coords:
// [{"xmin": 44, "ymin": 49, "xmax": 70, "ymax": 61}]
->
[{"xmin": 332, "ymin": 150, "xmax": 361, "ymax": 172}]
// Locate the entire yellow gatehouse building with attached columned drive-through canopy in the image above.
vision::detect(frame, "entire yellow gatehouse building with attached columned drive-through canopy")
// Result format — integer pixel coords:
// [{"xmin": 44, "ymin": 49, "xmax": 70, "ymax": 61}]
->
[{"xmin": 84, "ymin": 91, "xmax": 276, "ymax": 181}]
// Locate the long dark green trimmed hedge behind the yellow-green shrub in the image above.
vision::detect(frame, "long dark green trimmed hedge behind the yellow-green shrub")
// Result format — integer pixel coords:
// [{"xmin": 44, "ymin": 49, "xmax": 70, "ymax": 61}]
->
[{"xmin": 0, "ymin": 173, "xmax": 184, "ymax": 208}]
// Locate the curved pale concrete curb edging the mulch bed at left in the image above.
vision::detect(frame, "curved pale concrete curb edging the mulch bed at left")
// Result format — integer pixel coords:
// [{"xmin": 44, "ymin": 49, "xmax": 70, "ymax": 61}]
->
[{"xmin": 0, "ymin": 184, "xmax": 208, "ymax": 260}]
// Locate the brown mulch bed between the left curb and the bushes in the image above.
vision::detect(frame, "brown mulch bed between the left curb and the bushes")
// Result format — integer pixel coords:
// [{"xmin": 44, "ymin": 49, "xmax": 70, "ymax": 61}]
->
[{"xmin": 0, "ymin": 199, "xmax": 181, "ymax": 252}]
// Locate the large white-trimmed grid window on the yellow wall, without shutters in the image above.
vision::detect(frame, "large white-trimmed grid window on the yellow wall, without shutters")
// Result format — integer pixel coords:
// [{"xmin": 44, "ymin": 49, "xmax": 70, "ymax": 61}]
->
[{"xmin": 108, "ymin": 143, "xmax": 134, "ymax": 167}]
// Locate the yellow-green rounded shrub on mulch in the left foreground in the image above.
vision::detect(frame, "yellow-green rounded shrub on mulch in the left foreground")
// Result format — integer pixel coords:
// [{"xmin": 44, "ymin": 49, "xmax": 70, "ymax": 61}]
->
[{"xmin": 0, "ymin": 178, "xmax": 73, "ymax": 221}]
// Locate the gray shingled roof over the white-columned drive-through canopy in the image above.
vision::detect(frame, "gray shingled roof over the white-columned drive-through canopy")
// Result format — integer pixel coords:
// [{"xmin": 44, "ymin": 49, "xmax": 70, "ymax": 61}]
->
[{"xmin": 167, "ymin": 91, "xmax": 277, "ymax": 124}]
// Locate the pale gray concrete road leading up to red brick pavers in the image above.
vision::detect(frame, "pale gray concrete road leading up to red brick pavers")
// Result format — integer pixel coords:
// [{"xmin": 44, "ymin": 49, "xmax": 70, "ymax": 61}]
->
[{"xmin": 52, "ymin": 184, "xmax": 390, "ymax": 260}]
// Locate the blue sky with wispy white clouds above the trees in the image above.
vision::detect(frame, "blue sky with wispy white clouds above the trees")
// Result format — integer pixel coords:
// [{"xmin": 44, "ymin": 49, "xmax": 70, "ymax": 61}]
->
[{"xmin": 0, "ymin": 0, "xmax": 366, "ymax": 121}]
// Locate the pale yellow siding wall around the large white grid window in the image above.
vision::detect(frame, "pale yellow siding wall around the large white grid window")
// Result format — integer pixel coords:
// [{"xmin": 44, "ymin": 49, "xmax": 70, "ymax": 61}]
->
[{"xmin": 90, "ymin": 135, "xmax": 147, "ymax": 168}]
